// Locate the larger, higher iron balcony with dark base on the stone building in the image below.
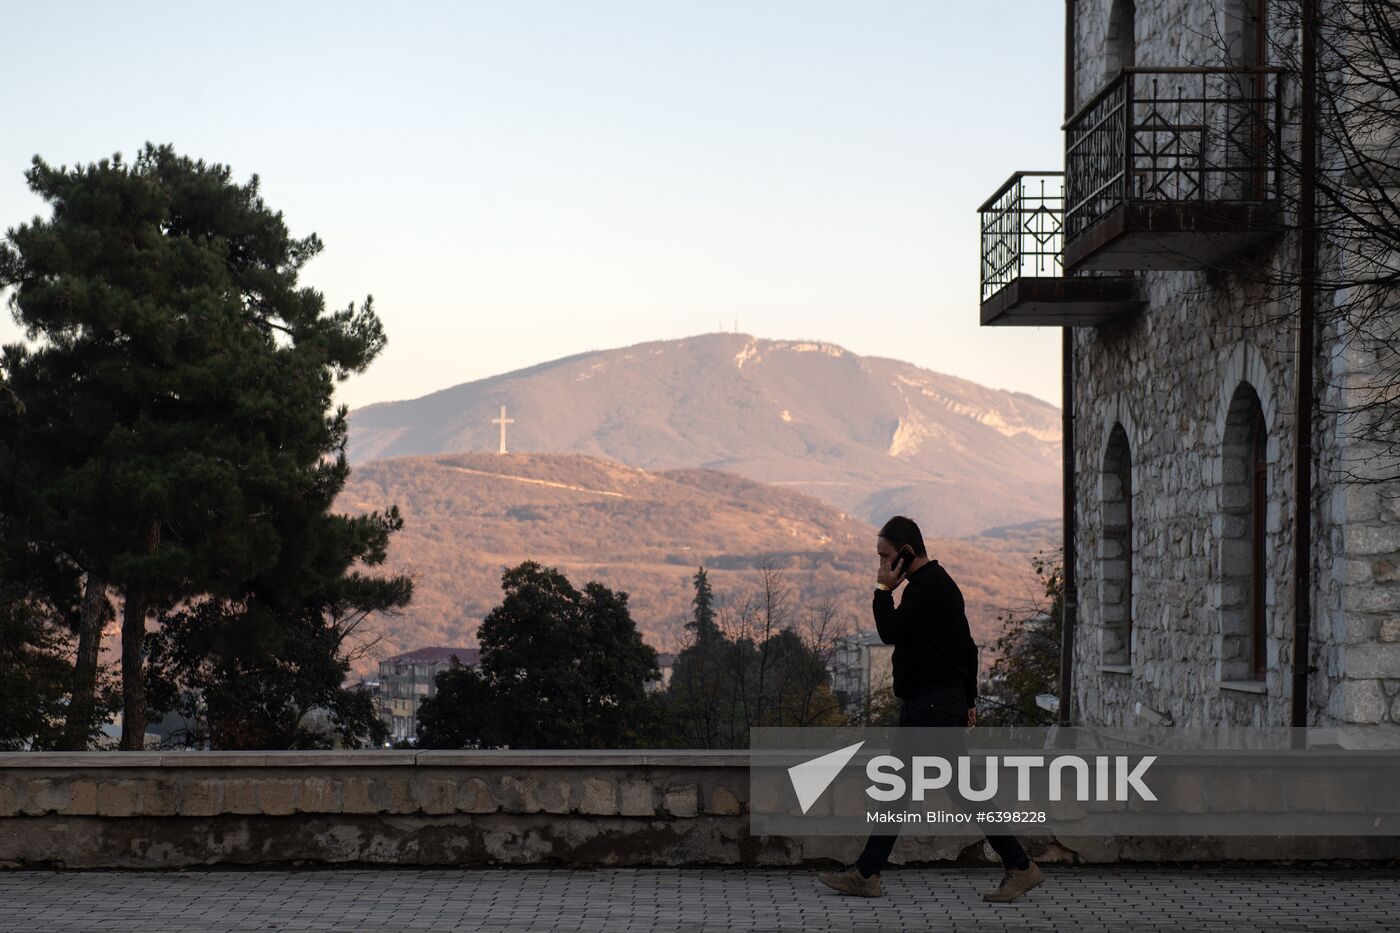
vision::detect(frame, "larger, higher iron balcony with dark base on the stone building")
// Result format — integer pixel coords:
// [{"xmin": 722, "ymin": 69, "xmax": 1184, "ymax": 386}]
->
[{"xmin": 1064, "ymin": 69, "xmax": 1280, "ymax": 270}]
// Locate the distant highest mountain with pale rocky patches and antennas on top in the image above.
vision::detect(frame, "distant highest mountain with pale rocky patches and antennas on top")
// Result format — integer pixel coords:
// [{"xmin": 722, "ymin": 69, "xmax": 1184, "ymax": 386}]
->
[{"xmin": 349, "ymin": 333, "xmax": 1060, "ymax": 537}]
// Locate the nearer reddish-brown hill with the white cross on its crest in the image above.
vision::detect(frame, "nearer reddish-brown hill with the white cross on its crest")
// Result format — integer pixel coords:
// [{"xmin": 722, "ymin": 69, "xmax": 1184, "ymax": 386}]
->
[{"xmin": 335, "ymin": 454, "xmax": 1054, "ymax": 675}]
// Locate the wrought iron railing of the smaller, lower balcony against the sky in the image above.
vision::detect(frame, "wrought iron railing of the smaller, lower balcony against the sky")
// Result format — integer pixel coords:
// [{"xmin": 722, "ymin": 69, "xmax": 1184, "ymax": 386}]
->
[{"xmin": 977, "ymin": 172, "xmax": 1064, "ymax": 301}]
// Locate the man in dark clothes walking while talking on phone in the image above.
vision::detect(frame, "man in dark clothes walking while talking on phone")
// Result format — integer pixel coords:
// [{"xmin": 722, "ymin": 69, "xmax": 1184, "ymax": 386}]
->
[{"xmin": 818, "ymin": 516, "xmax": 1044, "ymax": 904}]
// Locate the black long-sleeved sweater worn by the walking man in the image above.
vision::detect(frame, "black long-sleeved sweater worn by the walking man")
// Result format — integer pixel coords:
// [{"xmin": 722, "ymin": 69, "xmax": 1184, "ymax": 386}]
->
[{"xmin": 874, "ymin": 560, "xmax": 977, "ymax": 709}]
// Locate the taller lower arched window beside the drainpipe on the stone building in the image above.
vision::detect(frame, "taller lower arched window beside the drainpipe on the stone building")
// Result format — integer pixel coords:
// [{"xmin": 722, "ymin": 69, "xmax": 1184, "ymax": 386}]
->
[{"xmin": 1219, "ymin": 382, "xmax": 1268, "ymax": 681}]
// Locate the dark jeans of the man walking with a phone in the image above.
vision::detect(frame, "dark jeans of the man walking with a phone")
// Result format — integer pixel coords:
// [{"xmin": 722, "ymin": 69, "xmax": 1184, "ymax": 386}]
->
[{"xmin": 855, "ymin": 685, "xmax": 1029, "ymax": 876}]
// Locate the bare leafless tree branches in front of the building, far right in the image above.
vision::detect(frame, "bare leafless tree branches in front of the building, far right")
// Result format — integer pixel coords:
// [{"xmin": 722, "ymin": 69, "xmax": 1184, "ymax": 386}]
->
[{"xmin": 1200, "ymin": 0, "xmax": 1400, "ymax": 485}]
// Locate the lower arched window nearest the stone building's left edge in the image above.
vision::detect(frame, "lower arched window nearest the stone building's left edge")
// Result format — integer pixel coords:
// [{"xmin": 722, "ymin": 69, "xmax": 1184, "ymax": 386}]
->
[{"xmin": 1099, "ymin": 424, "xmax": 1133, "ymax": 665}]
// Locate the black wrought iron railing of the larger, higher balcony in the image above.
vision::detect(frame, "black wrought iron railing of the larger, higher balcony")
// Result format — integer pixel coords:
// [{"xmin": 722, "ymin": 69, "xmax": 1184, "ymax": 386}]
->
[{"xmin": 1064, "ymin": 67, "xmax": 1280, "ymax": 240}]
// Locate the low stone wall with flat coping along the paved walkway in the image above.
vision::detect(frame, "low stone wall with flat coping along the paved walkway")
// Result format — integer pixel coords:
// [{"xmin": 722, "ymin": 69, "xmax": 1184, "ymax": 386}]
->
[{"xmin": 0, "ymin": 751, "xmax": 1400, "ymax": 869}]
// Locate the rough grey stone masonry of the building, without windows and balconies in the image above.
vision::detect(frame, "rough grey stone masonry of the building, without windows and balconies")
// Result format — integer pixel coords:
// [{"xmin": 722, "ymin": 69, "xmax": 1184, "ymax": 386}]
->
[{"xmin": 1074, "ymin": 0, "xmax": 1400, "ymax": 728}]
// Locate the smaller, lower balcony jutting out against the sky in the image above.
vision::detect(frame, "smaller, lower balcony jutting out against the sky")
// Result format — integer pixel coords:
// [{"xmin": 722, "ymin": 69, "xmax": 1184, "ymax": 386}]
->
[{"xmin": 977, "ymin": 172, "xmax": 1142, "ymax": 326}]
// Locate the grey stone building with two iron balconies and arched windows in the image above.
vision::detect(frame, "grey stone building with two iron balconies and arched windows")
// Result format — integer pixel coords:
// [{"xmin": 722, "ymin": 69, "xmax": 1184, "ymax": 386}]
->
[{"xmin": 980, "ymin": 0, "xmax": 1400, "ymax": 726}]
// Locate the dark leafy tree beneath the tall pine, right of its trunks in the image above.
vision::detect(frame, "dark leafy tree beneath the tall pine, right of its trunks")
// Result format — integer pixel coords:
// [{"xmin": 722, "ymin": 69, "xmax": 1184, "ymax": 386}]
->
[{"xmin": 147, "ymin": 502, "xmax": 412, "ymax": 748}]
